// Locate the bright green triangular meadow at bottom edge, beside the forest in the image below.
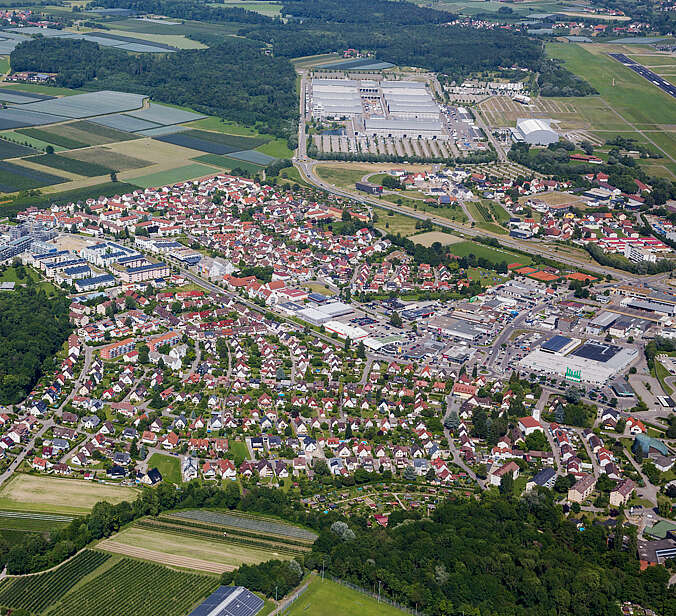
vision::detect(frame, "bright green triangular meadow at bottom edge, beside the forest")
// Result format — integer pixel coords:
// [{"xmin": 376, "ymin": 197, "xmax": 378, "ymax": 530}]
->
[{"xmin": 284, "ymin": 576, "xmax": 406, "ymax": 616}]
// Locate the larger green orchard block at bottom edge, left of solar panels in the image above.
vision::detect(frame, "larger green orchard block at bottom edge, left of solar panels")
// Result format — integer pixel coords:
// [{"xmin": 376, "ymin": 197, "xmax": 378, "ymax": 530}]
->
[{"xmin": 47, "ymin": 558, "xmax": 218, "ymax": 616}]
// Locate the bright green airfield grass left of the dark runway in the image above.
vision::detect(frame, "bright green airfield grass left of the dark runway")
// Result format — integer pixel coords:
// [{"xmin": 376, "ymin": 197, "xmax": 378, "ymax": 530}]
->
[{"xmin": 546, "ymin": 43, "xmax": 676, "ymax": 130}]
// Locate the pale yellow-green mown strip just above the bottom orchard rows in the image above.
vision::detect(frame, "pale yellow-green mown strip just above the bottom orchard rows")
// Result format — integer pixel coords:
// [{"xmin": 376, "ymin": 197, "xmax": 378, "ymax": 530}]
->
[{"xmin": 99, "ymin": 527, "xmax": 282, "ymax": 571}]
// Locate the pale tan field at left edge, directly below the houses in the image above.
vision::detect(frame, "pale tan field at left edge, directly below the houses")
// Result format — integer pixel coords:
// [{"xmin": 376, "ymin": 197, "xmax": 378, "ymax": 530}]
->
[{"xmin": 0, "ymin": 473, "xmax": 138, "ymax": 514}]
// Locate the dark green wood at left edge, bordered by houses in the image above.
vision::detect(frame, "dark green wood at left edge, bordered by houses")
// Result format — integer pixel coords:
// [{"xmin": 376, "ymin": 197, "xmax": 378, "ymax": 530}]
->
[{"xmin": 0, "ymin": 285, "xmax": 71, "ymax": 404}]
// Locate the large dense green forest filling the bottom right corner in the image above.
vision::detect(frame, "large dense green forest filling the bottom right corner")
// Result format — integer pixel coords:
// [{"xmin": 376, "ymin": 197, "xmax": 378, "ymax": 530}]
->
[{"xmin": 305, "ymin": 493, "xmax": 676, "ymax": 616}]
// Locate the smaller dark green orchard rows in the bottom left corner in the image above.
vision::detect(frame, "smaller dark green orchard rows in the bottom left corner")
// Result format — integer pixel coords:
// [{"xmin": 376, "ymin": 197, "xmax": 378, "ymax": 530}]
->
[{"xmin": 0, "ymin": 550, "xmax": 110, "ymax": 614}]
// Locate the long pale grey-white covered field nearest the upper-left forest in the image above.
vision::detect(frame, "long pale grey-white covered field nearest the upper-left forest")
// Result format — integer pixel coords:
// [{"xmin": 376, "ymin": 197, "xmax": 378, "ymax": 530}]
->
[{"xmin": 20, "ymin": 90, "xmax": 146, "ymax": 122}]
